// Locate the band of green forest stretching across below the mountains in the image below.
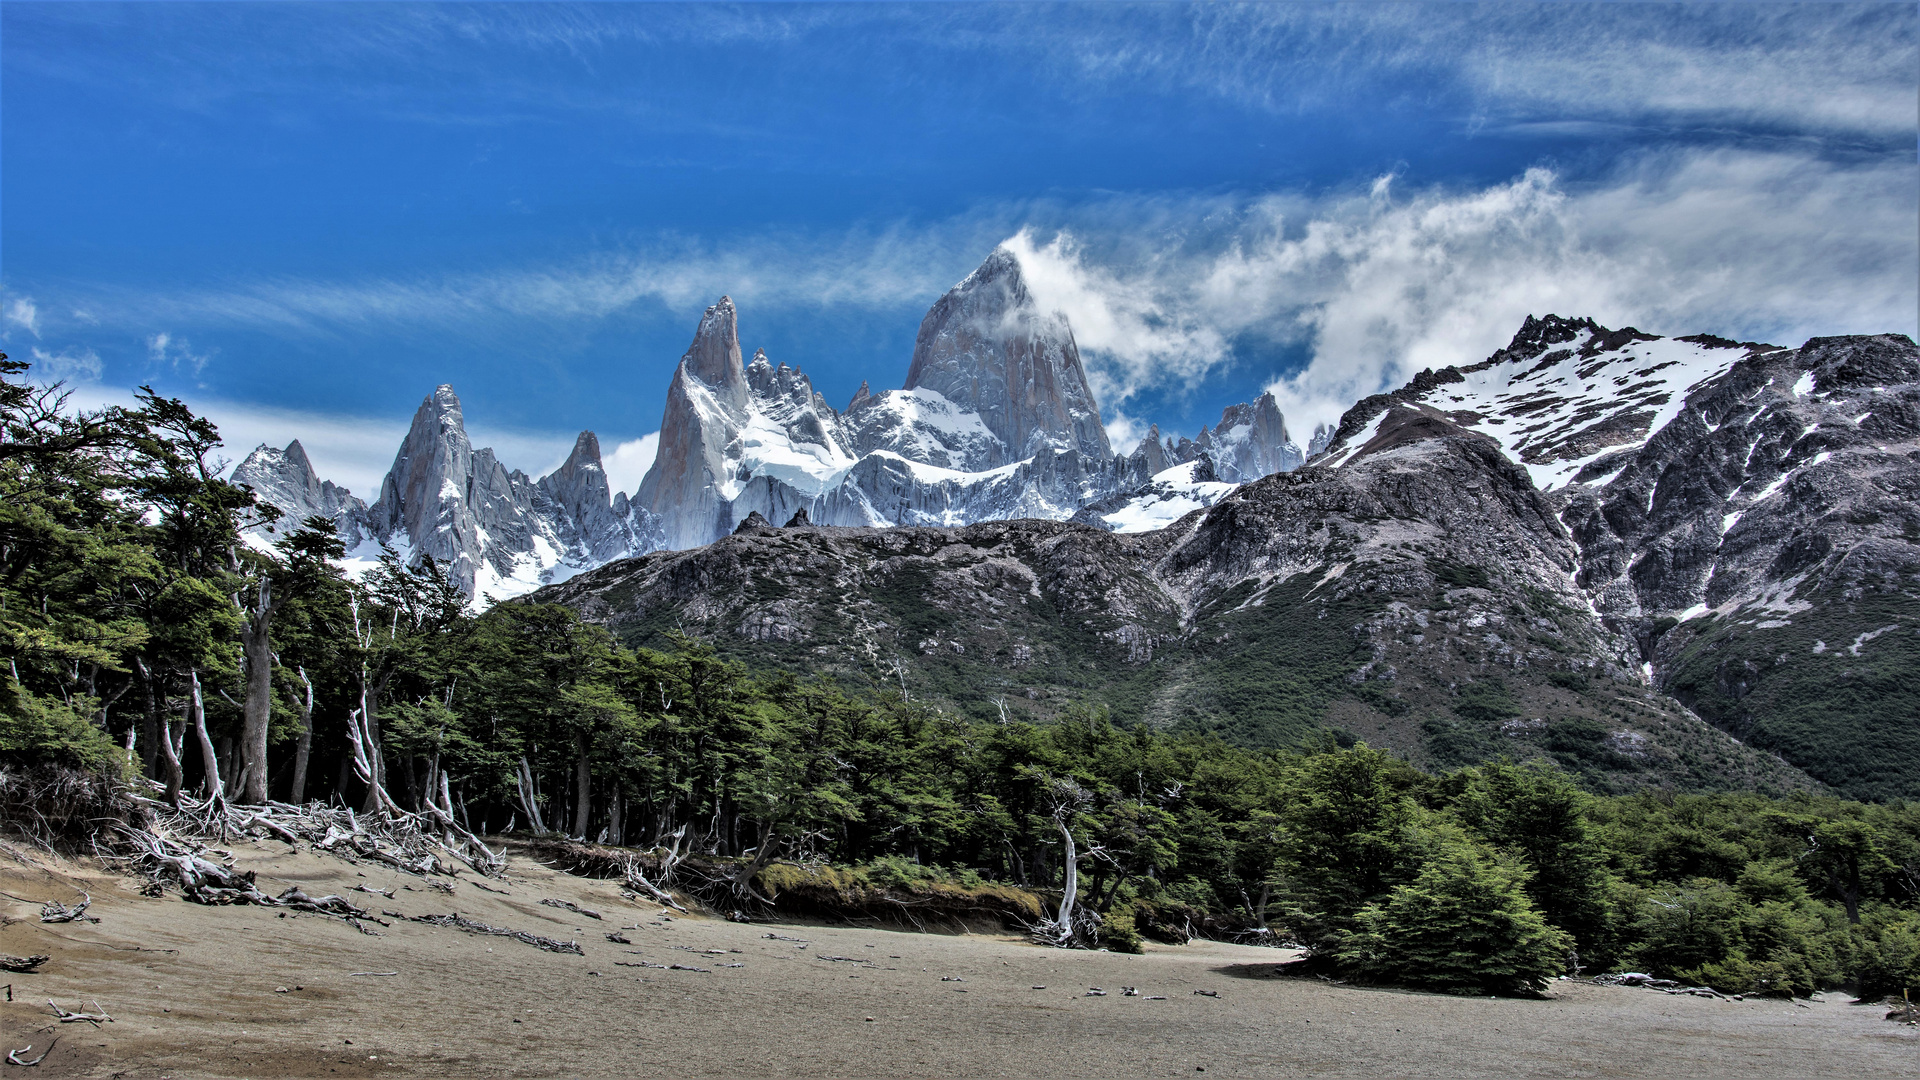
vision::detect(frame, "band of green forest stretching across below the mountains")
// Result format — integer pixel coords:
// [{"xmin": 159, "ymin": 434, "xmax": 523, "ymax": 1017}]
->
[{"xmin": 0, "ymin": 357, "xmax": 1920, "ymax": 997}]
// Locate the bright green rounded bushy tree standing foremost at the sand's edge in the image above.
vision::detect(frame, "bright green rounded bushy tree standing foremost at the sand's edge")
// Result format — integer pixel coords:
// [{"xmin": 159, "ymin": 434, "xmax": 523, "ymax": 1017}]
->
[{"xmin": 1336, "ymin": 828, "xmax": 1572, "ymax": 994}]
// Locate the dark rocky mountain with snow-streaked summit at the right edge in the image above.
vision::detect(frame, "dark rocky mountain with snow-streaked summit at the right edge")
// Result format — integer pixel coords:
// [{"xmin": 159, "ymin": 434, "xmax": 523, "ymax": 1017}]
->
[{"xmin": 1315, "ymin": 315, "xmax": 1920, "ymax": 798}]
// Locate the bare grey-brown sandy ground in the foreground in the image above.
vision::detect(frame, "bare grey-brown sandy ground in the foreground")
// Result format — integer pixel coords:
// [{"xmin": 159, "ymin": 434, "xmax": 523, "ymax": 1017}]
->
[{"xmin": 0, "ymin": 842, "xmax": 1920, "ymax": 1076}]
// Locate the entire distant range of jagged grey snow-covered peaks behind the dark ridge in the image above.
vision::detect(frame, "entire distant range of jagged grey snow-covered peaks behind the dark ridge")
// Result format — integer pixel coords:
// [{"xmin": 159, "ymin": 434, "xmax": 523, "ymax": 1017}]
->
[{"xmin": 234, "ymin": 248, "xmax": 1304, "ymax": 598}]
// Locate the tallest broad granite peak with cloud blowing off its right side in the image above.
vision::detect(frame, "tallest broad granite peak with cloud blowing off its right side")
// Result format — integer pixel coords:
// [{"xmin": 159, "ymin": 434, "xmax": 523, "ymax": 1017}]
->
[{"xmin": 904, "ymin": 246, "xmax": 1114, "ymax": 465}]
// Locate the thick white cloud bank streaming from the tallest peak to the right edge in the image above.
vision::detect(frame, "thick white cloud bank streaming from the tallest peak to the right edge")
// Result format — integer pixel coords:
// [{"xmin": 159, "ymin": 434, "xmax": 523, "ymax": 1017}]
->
[{"xmin": 1008, "ymin": 150, "xmax": 1920, "ymax": 430}]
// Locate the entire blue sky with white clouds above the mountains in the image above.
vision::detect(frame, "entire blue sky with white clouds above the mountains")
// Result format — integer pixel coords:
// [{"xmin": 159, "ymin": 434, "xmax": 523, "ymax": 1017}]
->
[{"xmin": 0, "ymin": 0, "xmax": 1920, "ymax": 494}]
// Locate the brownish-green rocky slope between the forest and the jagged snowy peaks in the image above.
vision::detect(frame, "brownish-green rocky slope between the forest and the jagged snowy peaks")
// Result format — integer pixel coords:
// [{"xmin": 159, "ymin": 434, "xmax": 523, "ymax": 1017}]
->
[{"xmin": 532, "ymin": 390, "xmax": 1807, "ymax": 788}]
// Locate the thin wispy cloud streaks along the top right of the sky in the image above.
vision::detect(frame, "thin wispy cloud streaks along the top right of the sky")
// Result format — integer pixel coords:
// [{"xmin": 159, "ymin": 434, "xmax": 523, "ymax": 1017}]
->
[{"xmin": 1052, "ymin": 4, "xmax": 1920, "ymax": 138}]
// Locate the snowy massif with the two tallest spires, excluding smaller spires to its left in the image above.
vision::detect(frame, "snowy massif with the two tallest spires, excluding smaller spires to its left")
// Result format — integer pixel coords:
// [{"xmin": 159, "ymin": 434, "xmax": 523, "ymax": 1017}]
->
[{"xmin": 634, "ymin": 248, "xmax": 1304, "ymax": 550}]
